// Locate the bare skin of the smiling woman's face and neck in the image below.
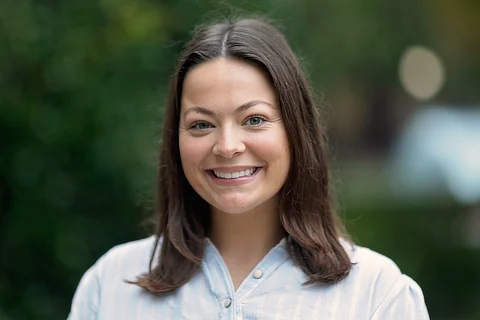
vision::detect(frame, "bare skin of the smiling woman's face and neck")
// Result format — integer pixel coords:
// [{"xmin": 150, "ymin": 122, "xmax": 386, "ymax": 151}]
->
[{"xmin": 179, "ymin": 58, "xmax": 290, "ymax": 287}]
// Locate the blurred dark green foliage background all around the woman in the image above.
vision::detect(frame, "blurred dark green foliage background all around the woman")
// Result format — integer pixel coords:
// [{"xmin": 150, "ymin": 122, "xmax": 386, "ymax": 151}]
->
[{"xmin": 0, "ymin": 0, "xmax": 480, "ymax": 320}]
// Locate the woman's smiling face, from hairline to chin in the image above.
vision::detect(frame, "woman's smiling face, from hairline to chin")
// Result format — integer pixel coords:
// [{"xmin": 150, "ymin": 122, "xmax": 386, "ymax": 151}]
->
[{"xmin": 179, "ymin": 58, "xmax": 290, "ymax": 214}]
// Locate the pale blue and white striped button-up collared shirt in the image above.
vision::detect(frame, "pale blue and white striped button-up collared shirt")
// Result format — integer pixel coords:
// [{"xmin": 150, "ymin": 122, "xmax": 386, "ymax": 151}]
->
[{"xmin": 68, "ymin": 236, "xmax": 429, "ymax": 320}]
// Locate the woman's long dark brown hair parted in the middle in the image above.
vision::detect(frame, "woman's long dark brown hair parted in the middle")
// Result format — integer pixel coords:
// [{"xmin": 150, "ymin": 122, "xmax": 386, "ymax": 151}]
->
[{"xmin": 131, "ymin": 18, "xmax": 351, "ymax": 294}]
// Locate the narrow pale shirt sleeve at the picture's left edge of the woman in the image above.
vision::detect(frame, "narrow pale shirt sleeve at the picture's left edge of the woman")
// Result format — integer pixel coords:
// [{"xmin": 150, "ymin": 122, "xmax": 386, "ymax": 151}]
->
[{"xmin": 67, "ymin": 263, "xmax": 101, "ymax": 320}]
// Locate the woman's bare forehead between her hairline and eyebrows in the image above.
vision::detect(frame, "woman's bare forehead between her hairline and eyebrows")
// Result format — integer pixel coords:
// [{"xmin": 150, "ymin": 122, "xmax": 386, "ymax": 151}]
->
[{"xmin": 181, "ymin": 58, "xmax": 276, "ymax": 109}]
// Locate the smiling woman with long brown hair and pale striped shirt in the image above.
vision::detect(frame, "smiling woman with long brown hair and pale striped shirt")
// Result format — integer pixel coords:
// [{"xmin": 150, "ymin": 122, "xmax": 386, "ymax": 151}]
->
[{"xmin": 69, "ymin": 19, "xmax": 428, "ymax": 320}]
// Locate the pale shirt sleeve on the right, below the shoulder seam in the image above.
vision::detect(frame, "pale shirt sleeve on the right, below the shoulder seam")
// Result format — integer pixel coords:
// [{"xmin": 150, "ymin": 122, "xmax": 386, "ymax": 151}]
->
[{"xmin": 371, "ymin": 275, "xmax": 430, "ymax": 320}]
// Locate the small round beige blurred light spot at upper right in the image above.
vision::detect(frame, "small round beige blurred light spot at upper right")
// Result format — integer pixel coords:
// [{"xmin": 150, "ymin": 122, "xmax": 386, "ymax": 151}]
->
[{"xmin": 399, "ymin": 46, "xmax": 445, "ymax": 101}]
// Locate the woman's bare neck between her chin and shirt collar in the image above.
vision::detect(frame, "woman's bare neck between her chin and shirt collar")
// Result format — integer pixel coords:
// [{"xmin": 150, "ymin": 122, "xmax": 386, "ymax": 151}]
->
[{"xmin": 210, "ymin": 200, "xmax": 286, "ymax": 269}]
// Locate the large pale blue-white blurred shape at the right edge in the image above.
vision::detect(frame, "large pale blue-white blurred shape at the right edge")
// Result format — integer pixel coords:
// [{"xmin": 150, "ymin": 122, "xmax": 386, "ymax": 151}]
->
[{"xmin": 391, "ymin": 107, "xmax": 480, "ymax": 204}]
